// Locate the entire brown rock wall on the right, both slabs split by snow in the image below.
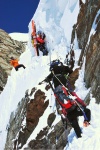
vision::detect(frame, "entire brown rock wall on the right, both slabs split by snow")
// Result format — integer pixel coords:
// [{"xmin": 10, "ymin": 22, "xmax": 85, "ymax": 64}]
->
[{"xmin": 71, "ymin": 0, "xmax": 100, "ymax": 103}]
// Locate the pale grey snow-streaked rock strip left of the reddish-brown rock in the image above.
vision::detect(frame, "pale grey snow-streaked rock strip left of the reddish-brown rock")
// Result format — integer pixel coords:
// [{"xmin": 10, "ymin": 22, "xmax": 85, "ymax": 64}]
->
[{"xmin": 5, "ymin": 91, "xmax": 30, "ymax": 150}]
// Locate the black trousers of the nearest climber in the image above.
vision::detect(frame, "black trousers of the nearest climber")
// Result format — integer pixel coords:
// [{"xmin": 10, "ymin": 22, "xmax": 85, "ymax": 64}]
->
[{"xmin": 67, "ymin": 107, "xmax": 91, "ymax": 138}]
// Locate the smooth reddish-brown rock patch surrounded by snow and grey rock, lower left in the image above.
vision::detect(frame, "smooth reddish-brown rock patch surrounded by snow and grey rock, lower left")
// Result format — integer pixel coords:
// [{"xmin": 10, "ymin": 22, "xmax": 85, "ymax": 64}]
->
[{"xmin": 26, "ymin": 90, "xmax": 48, "ymax": 131}]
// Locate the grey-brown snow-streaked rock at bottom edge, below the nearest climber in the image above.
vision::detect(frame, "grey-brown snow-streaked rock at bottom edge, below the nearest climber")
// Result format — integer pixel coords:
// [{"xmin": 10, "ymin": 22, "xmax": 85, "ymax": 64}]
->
[{"xmin": 24, "ymin": 121, "xmax": 71, "ymax": 150}]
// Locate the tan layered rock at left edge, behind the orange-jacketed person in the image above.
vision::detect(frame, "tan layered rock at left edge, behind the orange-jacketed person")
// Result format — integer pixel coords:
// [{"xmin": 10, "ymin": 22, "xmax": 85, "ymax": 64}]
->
[{"xmin": 0, "ymin": 29, "xmax": 25, "ymax": 91}]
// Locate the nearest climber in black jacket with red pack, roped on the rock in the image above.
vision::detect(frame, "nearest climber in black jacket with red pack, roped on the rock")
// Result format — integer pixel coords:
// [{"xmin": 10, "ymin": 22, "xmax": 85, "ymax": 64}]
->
[{"xmin": 44, "ymin": 60, "xmax": 91, "ymax": 138}]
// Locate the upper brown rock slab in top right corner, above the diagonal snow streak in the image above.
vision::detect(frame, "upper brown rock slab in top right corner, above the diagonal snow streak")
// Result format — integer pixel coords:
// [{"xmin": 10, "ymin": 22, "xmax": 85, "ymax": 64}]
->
[{"xmin": 76, "ymin": 0, "xmax": 100, "ymax": 50}]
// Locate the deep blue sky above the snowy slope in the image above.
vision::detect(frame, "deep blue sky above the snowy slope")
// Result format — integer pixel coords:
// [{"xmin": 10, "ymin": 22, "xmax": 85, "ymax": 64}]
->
[{"xmin": 0, "ymin": 0, "xmax": 40, "ymax": 33}]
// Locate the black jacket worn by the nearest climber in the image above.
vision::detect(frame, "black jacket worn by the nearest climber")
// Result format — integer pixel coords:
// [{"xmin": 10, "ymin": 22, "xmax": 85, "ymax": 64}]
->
[{"xmin": 46, "ymin": 65, "xmax": 73, "ymax": 88}]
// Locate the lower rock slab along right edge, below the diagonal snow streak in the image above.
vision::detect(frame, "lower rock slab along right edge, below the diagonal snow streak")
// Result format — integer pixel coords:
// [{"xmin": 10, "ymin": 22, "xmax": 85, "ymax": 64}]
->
[{"xmin": 85, "ymin": 22, "xmax": 100, "ymax": 103}]
